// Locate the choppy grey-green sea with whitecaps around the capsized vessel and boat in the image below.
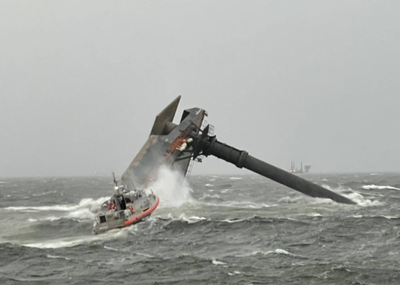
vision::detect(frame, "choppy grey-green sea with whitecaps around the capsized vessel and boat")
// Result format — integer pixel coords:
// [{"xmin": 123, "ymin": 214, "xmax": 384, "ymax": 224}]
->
[{"xmin": 0, "ymin": 173, "xmax": 400, "ymax": 284}]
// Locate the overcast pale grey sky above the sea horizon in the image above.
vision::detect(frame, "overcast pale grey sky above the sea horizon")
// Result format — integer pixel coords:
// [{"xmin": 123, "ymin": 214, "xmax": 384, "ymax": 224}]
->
[{"xmin": 0, "ymin": 0, "xmax": 400, "ymax": 177}]
